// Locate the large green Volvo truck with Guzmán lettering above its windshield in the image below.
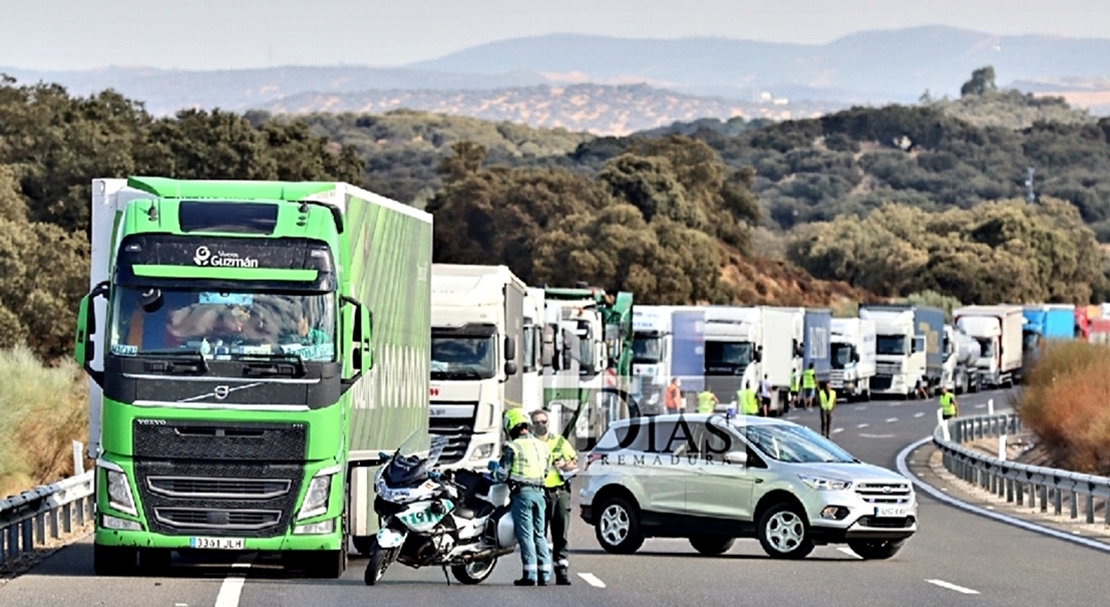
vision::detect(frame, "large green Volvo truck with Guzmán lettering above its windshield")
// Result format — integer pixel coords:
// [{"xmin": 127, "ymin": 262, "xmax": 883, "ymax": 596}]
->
[{"xmin": 75, "ymin": 178, "xmax": 432, "ymax": 578}]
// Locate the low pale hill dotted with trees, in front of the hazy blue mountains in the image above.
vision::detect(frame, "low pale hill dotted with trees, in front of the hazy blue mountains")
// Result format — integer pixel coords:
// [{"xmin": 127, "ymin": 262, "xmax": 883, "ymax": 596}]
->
[{"xmin": 261, "ymin": 84, "xmax": 842, "ymax": 135}]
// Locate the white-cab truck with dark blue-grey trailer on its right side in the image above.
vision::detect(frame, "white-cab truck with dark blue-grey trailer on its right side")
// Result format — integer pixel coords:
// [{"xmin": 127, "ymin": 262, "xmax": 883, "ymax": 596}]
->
[{"xmin": 859, "ymin": 304, "xmax": 945, "ymax": 397}]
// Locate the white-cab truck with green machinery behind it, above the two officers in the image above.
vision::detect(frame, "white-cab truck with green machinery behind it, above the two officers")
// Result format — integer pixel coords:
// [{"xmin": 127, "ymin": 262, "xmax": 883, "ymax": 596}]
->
[{"xmin": 544, "ymin": 286, "xmax": 636, "ymax": 449}]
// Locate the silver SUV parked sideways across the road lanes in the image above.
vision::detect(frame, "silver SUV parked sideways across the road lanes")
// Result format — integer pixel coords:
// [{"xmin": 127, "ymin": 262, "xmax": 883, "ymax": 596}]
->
[{"xmin": 581, "ymin": 414, "xmax": 917, "ymax": 559}]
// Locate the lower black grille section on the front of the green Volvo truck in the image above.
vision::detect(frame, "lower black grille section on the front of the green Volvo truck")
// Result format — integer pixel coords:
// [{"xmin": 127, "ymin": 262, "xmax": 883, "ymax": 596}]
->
[{"xmin": 134, "ymin": 459, "xmax": 304, "ymax": 537}]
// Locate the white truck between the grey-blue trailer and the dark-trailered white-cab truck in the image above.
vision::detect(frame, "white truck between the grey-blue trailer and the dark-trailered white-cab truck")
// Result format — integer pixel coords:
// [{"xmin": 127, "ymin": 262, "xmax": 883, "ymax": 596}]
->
[{"xmin": 829, "ymin": 318, "xmax": 876, "ymax": 402}]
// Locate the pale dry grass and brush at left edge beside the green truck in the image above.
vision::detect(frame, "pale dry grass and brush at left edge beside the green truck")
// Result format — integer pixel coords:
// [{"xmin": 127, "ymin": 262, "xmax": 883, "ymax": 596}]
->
[{"xmin": 0, "ymin": 346, "xmax": 88, "ymax": 496}]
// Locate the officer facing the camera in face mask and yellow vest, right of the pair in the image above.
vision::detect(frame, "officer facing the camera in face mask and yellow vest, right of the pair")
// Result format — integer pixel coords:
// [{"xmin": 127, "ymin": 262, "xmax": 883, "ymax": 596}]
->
[{"xmin": 532, "ymin": 409, "xmax": 578, "ymax": 586}]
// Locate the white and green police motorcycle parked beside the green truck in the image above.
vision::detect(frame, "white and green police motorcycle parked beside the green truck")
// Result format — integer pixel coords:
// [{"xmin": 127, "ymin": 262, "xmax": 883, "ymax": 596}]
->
[{"xmin": 363, "ymin": 431, "xmax": 516, "ymax": 586}]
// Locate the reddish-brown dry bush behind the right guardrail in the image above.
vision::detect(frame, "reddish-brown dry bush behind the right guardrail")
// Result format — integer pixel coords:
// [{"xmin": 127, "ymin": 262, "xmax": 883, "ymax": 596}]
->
[{"xmin": 1015, "ymin": 342, "xmax": 1110, "ymax": 475}]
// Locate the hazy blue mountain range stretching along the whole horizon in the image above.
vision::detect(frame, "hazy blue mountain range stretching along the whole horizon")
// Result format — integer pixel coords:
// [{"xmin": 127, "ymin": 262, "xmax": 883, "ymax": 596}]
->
[{"xmin": 0, "ymin": 27, "xmax": 1110, "ymax": 121}]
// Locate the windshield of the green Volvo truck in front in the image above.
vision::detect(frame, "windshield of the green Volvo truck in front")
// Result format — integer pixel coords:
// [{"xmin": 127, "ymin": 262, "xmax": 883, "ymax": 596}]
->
[{"xmin": 110, "ymin": 285, "xmax": 336, "ymax": 362}]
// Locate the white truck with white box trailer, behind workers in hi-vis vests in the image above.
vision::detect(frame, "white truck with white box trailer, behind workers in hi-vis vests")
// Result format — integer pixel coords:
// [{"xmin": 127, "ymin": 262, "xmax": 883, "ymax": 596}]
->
[{"xmin": 704, "ymin": 306, "xmax": 805, "ymax": 415}]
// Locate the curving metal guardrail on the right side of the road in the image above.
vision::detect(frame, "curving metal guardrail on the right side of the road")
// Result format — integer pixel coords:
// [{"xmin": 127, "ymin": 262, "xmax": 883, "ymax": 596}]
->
[{"xmin": 932, "ymin": 413, "xmax": 1110, "ymax": 525}]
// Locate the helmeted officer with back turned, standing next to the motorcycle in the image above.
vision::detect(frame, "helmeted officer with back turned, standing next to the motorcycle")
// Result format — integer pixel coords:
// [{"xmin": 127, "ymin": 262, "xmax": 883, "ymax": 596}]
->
[{"xmin": 490, "ymin": 407, "xmax": 552, "ymax": 586}]
